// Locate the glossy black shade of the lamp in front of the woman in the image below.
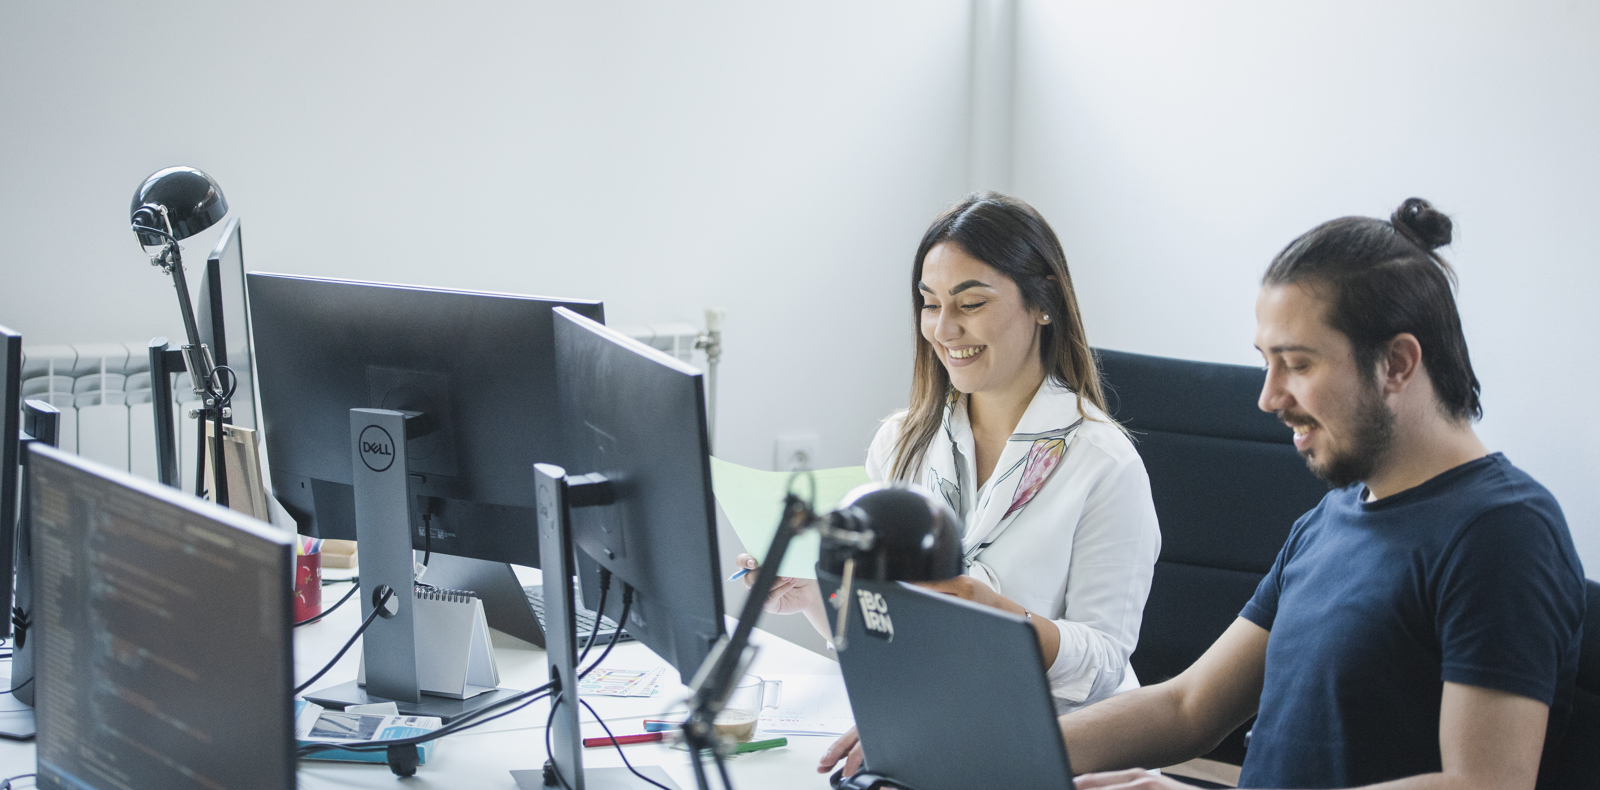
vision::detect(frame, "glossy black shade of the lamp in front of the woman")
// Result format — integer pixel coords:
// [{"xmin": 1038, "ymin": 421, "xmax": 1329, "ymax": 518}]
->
[{"xmin": 818, "ymin": 483, "xmax": 965, "ymax": 582}]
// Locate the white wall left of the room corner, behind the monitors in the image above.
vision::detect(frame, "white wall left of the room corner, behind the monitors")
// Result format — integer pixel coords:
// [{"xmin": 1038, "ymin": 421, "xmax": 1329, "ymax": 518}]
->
[{"xmin": 0, "ymin": 0, "xmax": 970, "ymax": 467}]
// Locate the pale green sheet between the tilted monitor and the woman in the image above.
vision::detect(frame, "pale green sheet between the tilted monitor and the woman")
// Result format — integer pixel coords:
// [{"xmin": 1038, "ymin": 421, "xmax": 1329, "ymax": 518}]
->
[{"xmin": 710, "ymin": 457, "xmax": 867, "ymax": 579}]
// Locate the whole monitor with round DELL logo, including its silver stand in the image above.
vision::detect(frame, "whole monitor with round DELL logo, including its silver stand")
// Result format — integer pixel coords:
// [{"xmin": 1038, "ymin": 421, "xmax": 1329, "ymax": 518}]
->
[{"xmin": 246, "ymin": 272, "xmax": 603, "ymax": 721}]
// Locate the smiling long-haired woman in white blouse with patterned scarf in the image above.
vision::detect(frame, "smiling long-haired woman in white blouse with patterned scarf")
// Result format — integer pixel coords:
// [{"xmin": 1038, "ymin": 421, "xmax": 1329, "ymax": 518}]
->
[{"xmin": 739, "ymin": 194, "xmax": 1162, "ymax": 772}]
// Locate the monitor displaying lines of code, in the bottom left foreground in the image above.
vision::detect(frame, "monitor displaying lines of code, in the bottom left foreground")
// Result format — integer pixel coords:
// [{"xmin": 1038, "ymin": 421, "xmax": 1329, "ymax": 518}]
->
[{"xmin": 29, "ymin": 443, "xmax": 294, "ymax": 790}]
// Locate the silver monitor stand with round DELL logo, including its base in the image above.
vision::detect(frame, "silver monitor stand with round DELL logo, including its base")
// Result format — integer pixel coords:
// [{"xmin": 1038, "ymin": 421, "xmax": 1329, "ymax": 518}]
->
[{"xmin": 306, "ymin": 409, "xmax": 517, "ymax": 723}]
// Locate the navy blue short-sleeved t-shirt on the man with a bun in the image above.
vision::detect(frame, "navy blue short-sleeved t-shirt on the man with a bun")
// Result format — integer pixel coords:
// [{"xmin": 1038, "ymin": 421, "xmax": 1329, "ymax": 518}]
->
[{"xmin": 1240, "ymin": 453, "xmax": 1584, "ymax": 788}]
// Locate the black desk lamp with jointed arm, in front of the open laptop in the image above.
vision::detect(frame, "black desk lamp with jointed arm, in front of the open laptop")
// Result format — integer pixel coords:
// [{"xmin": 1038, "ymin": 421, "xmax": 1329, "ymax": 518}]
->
[{"xmin": 683, "ymin": 482, "xmax": 963, "ymax": 790}]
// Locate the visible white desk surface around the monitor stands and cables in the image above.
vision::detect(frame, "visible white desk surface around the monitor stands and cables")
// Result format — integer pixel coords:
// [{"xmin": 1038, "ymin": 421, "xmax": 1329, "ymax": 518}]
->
[{"xmin": 0, "ymin": 573, "xmax": 838, "ymax": 790}]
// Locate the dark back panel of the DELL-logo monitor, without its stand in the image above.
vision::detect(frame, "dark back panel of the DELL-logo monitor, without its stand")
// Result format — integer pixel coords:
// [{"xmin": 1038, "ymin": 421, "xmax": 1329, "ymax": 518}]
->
[{"xmin": 246, "ymin": 272, "xmax": 603, "ymax": 568}]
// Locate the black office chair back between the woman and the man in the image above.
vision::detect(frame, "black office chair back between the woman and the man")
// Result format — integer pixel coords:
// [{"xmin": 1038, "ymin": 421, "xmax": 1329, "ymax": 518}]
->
[{"xmin": 1096, "ymin": 350, "xmax": 1328, "ymax": 764}]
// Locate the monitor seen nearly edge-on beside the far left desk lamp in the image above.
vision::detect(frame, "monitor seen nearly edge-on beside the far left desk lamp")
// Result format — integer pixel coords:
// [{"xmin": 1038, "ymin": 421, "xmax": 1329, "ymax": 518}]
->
[{"xmin": 195, "ymin": 217, "xmax": 256, "ymax": 429}]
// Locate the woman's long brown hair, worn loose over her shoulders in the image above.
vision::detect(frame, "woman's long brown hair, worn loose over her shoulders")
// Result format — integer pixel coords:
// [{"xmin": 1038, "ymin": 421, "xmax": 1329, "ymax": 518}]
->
[{"xmin": 891, "ymin": 192, "xmax": 1110, "ymax": 480}]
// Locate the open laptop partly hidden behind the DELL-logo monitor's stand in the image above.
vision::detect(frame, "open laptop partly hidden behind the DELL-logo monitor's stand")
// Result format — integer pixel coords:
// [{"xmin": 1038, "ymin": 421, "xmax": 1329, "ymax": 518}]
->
[{"xmin": 422, "ymin": 553, "xmax": 632, "ymax": 648}]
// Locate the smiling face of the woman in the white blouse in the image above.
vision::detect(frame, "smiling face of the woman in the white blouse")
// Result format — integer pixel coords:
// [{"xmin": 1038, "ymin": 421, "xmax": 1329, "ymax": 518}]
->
[{"xmin": 917, "ymin": 241, "xmax": 1048, "ymax": 393}]
